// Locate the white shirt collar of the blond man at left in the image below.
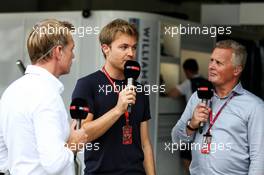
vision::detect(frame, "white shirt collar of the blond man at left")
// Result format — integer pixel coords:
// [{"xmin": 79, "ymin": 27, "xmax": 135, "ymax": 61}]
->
[{"xmin": 25, "ymin": 65, "xmax": 64, "ymax": 94}]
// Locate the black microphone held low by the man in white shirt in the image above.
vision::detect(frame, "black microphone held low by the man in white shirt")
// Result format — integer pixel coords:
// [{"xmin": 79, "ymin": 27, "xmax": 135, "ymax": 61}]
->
[{"xmin": 70, "ymin": 98, "xmax": 89, "ymax": 129}]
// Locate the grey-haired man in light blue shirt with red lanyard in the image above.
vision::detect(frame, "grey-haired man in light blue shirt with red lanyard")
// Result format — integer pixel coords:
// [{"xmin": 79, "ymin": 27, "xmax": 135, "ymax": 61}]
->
[{"xmin": 172, "ymin": 40, "xmax": 264, "ymax": 175}]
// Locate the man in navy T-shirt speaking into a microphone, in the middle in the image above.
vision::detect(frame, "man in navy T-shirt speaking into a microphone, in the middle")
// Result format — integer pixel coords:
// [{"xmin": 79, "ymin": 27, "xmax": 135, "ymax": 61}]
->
[{"xmin": 72, "ymin": 19, "xmax": 155, "ymax": 175}]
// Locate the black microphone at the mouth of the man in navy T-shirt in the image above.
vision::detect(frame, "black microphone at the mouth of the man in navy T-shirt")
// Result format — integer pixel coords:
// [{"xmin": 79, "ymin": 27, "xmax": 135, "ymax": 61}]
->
[{"xmin": 124, "ymin": 60, "xmax": 140, "ymax": 113}]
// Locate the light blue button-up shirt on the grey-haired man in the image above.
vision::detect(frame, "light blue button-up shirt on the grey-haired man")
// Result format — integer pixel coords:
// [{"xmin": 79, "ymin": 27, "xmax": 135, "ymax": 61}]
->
[{"xmin": 171, "ymin": 83, "xmax": 264, "ymax": 175}]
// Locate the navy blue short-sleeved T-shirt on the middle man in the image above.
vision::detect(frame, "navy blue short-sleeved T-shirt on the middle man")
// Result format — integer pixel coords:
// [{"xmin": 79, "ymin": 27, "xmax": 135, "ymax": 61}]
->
[{"xmin": 72, "ymin": 71, "xmax": 150, "ymax": 175}]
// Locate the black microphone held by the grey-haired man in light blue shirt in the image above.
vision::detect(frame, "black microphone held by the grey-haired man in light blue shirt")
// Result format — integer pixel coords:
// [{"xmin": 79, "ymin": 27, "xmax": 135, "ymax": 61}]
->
[{"xmin": 197, "ymin": 81, "xmax": 214, "ymax": 134}]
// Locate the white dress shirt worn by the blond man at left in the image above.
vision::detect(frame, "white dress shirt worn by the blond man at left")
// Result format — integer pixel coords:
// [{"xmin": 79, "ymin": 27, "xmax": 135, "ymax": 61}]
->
[{"xmin": 0, "ymin": 66, "xmax": 74, "ymax": 175}]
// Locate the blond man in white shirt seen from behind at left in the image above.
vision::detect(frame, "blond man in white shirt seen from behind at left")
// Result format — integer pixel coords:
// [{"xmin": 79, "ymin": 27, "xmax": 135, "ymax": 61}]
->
[{"xmin": 0, "ymin": 19, "xmax": 87, "ymax": 175}]
